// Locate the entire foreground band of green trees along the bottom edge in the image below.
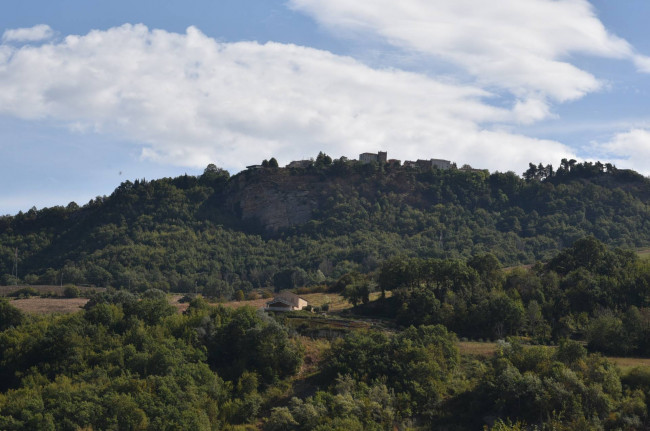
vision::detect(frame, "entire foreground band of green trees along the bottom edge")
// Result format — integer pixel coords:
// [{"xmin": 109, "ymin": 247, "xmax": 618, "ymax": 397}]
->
[{"xmin": 0, "ymin": 291, "xmax": 650, "ymax": 431}]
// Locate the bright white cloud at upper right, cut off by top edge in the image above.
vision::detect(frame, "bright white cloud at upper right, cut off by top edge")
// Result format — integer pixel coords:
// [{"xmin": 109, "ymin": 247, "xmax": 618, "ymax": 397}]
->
[{"xmin": 289, "ymin": 0, "xmax": 650, "ymax": 111}]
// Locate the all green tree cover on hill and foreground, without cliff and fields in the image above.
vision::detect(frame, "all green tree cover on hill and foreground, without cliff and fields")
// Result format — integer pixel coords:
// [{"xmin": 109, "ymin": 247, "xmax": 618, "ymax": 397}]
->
[{"xmin": 0, "ymin": 158, "xmax": 650, "ymax": 431}]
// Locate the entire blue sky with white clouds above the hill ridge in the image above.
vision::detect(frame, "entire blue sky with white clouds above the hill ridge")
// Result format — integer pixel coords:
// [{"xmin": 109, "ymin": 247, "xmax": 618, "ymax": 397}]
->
[{"xmin": 0, "ymin": 0, "xmax": 650, "ymax": 214}]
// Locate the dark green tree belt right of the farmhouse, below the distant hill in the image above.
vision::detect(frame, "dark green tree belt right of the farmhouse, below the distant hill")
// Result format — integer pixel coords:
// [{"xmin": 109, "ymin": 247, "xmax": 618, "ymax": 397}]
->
[{"xmin": 362, "ymin": 237, "xmax": 650, "ymax": 355}]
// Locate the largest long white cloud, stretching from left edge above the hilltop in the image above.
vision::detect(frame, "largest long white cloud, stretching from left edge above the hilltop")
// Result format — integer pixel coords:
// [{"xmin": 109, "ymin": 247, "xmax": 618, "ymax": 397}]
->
[{"xmin": 0, "ymin": 25, "xmax": 574, "ymax": 170}]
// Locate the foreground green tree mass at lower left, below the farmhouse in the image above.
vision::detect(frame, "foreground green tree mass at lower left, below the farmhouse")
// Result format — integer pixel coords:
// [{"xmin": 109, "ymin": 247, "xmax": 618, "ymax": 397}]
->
[{"xmin": 0, "ymin": 290, "xmax": 303, "ymax": 431}]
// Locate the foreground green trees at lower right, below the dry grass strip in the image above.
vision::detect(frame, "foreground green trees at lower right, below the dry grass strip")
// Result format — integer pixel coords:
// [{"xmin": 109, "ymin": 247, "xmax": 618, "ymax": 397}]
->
[{"xmin": 266, "ymin": 332, "xmax": 650, "ymax": 431}]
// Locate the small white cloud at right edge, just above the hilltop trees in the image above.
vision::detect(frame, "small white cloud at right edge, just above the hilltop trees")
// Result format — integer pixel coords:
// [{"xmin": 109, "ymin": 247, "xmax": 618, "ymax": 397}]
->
[{"xmin": 591, "ymin": 129, "xmax": 650, "ymax": 175}]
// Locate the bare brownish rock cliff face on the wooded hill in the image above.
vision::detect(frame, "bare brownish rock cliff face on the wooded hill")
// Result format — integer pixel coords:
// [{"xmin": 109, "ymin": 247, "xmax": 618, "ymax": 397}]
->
[{"xmin": 230, "ymin": 173, "xmax": 320, "ymax": 232}]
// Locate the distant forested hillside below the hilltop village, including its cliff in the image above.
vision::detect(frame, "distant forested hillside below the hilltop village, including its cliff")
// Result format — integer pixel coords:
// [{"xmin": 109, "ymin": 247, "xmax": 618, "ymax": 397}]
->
[{"xmin": 0, "ymin": 154, "xmax": 650, "ymax": 298}]
